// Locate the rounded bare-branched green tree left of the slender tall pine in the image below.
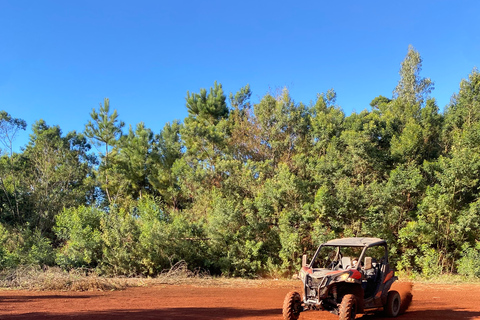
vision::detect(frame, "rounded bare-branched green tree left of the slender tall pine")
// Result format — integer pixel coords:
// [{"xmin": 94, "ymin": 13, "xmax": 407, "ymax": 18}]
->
[{"xmin": 21, "ymin": 120, "xmax": 95, "ymax": 233}]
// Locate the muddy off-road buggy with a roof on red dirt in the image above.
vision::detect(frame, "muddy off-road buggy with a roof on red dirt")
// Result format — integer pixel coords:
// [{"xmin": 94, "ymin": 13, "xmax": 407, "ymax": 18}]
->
[{"xmin": 283, "ymin": 238, "xmax": 401, "ymax": 320}]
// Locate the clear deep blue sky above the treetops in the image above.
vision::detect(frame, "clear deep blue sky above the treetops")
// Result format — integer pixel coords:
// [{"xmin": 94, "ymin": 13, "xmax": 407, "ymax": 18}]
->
[{"xmin": 0, "ymin": 0, "xmax": 480, "ymax": 151}]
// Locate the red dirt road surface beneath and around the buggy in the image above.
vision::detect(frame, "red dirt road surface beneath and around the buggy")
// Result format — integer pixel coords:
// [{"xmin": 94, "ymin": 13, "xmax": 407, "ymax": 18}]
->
[{"xmin": 0, "ymin": 281, "xmax": 480, "ymax": 320}]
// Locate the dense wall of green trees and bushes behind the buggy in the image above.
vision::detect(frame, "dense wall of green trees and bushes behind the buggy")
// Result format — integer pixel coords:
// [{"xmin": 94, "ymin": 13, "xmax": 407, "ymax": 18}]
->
[{"xmin": 0, "ymin": 46, "xmax": 480, "ymax": 278}]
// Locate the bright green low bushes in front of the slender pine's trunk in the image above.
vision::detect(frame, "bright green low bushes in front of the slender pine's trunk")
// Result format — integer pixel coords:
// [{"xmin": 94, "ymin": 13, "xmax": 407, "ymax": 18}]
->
[{"xmin": 51, "ymin": 196, "xmax": 211, "ymax": 276}]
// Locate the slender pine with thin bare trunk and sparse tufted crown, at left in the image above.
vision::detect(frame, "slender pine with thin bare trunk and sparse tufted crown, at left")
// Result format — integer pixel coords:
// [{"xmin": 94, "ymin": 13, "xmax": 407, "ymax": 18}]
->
[{"xmin": 85, "ymin": 98, "xmax": 125, "ymax": 203}]
